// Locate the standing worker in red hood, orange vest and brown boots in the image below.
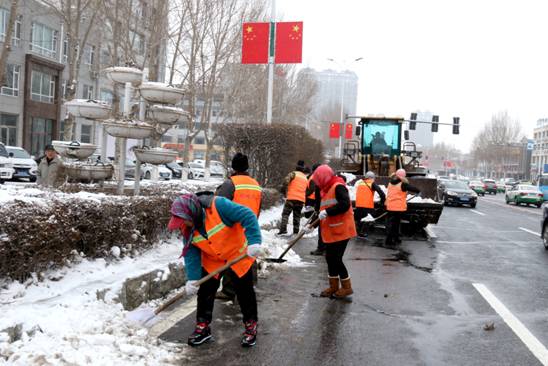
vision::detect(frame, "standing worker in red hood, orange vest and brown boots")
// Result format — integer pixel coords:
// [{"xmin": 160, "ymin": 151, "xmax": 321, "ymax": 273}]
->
[{"xmin": 313, "ymin": 165, "xmax": 356, "ymax": 298}]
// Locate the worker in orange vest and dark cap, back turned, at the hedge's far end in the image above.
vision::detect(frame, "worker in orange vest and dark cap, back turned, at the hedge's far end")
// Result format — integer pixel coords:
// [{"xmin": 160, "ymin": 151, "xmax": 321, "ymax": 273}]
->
[{"xmin": 278, "ymin": 160, "xmax": 308, "ymax": 235}]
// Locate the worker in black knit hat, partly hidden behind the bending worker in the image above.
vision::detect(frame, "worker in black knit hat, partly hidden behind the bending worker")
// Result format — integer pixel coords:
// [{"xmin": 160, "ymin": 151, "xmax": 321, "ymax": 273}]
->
[{"xmin": 215, "ymin": 153, "xmax": 262, "ymax": 300}]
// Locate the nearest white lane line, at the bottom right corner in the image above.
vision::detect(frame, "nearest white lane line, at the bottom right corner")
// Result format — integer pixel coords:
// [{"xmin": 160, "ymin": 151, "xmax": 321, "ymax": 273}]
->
[{"xmin": 473, "ymin": 283, "xmax": 548, "ymax": 366}]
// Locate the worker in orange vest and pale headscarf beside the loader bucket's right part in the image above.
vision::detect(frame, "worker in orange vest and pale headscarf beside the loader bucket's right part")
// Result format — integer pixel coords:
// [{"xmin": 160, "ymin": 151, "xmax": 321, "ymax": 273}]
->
[{"xmin": 385, "ymin": 169, "xmax": 420, "ymax": 248}]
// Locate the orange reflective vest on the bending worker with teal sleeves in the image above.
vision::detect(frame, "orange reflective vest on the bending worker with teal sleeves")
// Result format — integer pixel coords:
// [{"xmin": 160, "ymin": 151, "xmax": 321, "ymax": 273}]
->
[{"xmin": 192, "ymin": 197, "xmax": 255, "ymax": 278}]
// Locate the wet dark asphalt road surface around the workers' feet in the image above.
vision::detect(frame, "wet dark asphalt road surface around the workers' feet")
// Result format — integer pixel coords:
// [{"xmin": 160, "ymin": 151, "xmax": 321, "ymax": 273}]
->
[{"xmin": 160, "ymin": 194, "xmax": 548, "ymax": 366}]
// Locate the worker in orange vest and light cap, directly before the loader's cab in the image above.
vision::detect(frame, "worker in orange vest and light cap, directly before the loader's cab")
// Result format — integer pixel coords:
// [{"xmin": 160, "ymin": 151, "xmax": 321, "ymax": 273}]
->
[{"xmin": 354, "ymin": 171, "xmax": 386, "ymax": 237}]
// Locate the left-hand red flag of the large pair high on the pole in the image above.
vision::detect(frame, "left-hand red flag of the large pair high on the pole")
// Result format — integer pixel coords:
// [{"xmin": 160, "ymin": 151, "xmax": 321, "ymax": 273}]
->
[{"xmin": 242, "ymin": 23, "xmax": 270, "ymax": 64}]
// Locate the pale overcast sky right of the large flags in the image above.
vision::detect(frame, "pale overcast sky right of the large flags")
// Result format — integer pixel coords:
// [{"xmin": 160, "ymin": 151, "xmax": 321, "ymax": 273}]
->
[{"xmin": 276, "ymin": 0, "xmax": 548, "ymax": 150}]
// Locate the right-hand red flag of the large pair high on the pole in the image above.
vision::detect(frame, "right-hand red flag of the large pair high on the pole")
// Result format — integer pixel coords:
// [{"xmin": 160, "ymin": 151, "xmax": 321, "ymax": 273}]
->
[{"xmin": 274, "ymin": 22, "xmax": 303, "ymax": 64}]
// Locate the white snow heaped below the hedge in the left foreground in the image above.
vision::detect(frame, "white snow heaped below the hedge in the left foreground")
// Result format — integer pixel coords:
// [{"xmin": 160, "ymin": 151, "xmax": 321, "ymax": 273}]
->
[{"xmin": 0, "ymin": 240, "xmax": 181, "ymax": 365}]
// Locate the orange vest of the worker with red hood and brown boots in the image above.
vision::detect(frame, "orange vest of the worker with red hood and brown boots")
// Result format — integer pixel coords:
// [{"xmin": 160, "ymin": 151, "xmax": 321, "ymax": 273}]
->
[{"xmin": 320, "ymin": 182, "xmax": 357, "ymax": 243}]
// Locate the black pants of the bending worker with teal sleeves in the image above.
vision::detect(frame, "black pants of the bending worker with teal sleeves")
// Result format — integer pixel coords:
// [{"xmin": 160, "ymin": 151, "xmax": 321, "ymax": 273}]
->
[{"xmin": 196, "ymin": 268, "xmax": 258, "ymax": 323}]
